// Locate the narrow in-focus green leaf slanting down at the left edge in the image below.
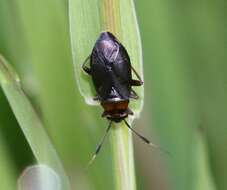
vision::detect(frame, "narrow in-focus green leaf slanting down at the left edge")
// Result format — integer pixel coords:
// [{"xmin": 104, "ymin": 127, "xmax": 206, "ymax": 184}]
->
[{"xmin": 0, "ymin": 55, "xmax": 69, "ymax": 190}]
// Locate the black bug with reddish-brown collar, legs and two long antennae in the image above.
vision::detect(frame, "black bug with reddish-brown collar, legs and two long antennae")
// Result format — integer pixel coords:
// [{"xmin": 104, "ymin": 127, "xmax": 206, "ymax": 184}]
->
[{"xmin": 82, "ymin": 31, "xmax": 159, "ymax": 163}]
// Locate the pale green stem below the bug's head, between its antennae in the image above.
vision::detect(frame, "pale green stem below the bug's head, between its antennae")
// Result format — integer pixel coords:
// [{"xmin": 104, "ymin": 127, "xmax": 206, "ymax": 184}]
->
[{"xmin": 111, "ymin": 123, "xmax": 136, "ymax": 190}]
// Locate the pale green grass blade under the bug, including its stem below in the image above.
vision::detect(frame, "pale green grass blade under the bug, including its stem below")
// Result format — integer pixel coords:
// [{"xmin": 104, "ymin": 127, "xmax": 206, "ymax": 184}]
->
[{"xmin": 69, "ymin": 0, "xmax": 144, "ymax": 190}]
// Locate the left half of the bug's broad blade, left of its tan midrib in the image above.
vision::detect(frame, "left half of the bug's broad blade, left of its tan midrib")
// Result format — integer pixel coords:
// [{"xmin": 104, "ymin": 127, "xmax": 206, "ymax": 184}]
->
[{"xmin": 69, "ymin": 0, "xmax": 101, "ymax": 105}]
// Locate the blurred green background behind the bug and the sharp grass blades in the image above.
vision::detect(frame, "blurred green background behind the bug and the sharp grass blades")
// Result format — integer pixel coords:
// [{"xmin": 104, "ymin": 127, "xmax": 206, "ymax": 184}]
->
[{"xmin": 0, "ymin": 0, "xmax": 227, "ymax": 190}]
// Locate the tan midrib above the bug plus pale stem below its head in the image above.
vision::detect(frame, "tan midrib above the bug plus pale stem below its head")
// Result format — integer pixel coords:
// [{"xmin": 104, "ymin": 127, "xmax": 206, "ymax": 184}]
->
[{"xmin": 102, "ymin": 0, "xmax": 136, "ymax": 190}]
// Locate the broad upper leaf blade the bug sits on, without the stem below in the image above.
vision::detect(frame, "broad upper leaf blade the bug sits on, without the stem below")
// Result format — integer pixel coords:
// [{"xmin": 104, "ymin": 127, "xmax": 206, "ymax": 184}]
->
[{"xmin": 69, "ymin": 0, "xmax": 144, "ymax": 116}]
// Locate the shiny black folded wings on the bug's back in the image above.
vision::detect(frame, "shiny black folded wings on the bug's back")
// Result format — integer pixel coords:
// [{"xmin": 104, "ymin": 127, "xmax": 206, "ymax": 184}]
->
[{"xmin": 91, "ymin": 37, "xmax": 131, "ymax": 100}]
